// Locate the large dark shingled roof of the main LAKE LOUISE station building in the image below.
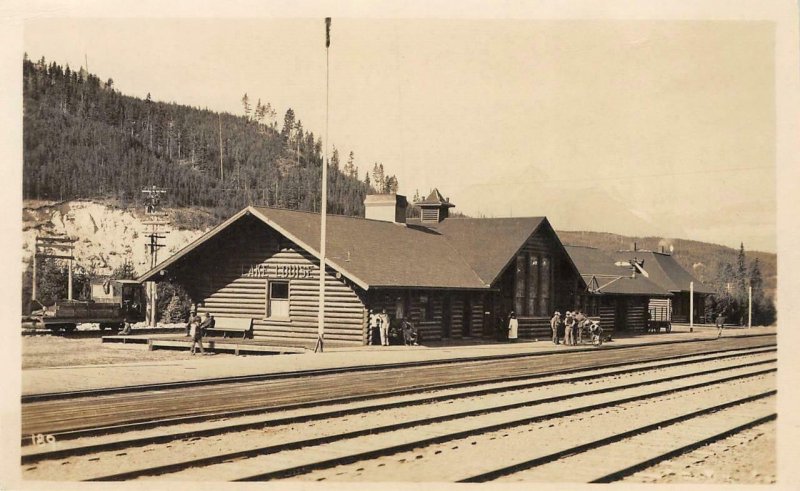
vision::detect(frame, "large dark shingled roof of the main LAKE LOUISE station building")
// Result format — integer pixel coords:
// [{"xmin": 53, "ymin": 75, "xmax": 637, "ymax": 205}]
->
[{"xmin": 138, "ymin": 207, "xmax": 577, "ymax": 289}]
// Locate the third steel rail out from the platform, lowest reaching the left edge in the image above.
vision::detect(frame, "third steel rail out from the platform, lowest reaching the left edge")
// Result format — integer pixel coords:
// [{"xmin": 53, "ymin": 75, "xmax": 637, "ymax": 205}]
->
[{"xmin": 21, "ymin": 353, "xmax": 777, "ymax": 464}]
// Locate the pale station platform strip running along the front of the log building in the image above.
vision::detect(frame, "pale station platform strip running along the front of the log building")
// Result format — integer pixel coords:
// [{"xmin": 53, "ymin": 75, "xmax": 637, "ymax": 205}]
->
[{"xmin": 22, "ymin": 325, "xmax": 777, "ymax": 396}]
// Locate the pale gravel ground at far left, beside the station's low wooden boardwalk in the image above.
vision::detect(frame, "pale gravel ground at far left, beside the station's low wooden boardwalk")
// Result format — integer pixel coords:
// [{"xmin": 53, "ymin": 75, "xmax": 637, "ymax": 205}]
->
[{"xmin": 22, "ymin": 336, "xmax": 233, "ymax": 370}]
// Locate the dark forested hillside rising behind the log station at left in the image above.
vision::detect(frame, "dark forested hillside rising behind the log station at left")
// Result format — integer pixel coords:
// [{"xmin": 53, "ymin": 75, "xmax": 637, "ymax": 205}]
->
[{"xmin": 23, "ymin": 56, "xmax": 397, "ymax": 218}]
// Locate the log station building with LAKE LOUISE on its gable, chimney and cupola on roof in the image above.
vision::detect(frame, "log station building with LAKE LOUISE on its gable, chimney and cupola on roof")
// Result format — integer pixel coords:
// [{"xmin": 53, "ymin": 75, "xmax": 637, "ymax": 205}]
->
[{"xmin": 139, "ymin": 190, "xmax": 712, "ymax": 346}]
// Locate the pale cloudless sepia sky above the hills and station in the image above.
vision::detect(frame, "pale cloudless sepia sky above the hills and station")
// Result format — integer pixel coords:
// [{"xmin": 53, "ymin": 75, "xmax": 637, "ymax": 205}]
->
[{"xmin": 23, "ymin": 16, "xmax": 776, "ymax": 252}]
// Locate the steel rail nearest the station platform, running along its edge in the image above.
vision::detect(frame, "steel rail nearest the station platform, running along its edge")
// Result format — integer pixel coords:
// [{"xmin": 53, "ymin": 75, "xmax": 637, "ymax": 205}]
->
[{"xmin": 21, "ymin": 333, "xmax": 777, "ymax": 404}]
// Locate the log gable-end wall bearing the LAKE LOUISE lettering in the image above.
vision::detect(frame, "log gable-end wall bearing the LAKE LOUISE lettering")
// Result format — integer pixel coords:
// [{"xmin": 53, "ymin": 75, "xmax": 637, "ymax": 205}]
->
[{"xmin": 172, "ymin": 217, "xmax": 366, "ymax": 346}]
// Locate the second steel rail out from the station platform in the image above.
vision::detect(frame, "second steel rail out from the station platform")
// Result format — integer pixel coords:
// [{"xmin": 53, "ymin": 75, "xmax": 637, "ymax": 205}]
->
[{"xmin": 21, "ymin": 347, "xmax": 776, "ymax": 445}]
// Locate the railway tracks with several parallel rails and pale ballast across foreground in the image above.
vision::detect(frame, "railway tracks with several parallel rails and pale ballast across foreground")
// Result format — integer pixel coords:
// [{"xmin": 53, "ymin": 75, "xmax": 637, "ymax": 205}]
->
[{"xmin": 23, "ymin": 347, "xmax": 776, "ymax": 482}]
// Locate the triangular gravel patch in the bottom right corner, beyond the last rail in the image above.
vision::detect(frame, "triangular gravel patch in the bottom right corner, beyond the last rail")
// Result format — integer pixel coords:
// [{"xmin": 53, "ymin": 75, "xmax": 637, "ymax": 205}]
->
[{"xmin": 623, "ymin": 422, "xmax": 776, "ymax": 484}]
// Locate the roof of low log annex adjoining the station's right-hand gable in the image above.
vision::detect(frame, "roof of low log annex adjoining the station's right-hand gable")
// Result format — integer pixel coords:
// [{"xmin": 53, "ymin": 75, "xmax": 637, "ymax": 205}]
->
[{"xmin": 564, "ymin": 245, "xmax": 672, "ymax": 297}]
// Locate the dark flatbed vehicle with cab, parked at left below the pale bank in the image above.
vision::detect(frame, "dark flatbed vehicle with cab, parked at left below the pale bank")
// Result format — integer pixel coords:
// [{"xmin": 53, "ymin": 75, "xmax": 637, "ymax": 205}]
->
[{"xmin": 23, "ymin": 279, "xmax": 146, "ymax": 332}]
